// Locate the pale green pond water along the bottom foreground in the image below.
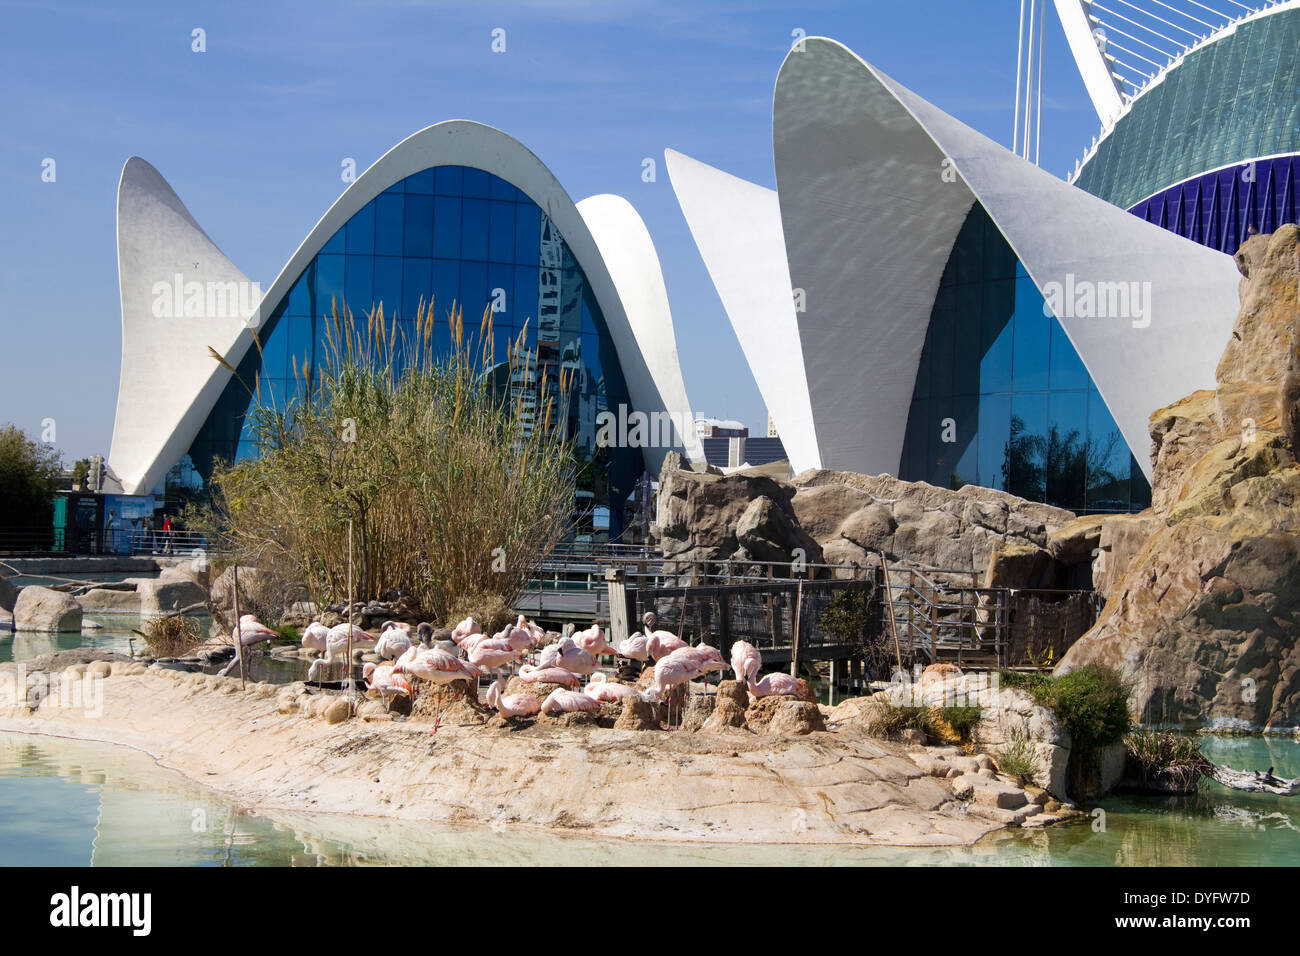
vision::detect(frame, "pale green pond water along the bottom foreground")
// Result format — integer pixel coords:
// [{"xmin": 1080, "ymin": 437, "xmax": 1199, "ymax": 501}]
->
[{"xmin": 0, "ymin": 734, "xmax": 1300, "ymax": 866}]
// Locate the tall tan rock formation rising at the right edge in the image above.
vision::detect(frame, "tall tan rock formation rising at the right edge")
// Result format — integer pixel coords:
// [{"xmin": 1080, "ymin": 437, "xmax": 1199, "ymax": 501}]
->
[{"xmin": 1058, "ymin": 225, "xmax": 1300, "ymax": 728}]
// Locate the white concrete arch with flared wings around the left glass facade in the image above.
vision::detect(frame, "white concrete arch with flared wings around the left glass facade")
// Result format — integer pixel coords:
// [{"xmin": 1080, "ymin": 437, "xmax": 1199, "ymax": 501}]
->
[{"xmin": 109, "ymin": 120, "xmax": 703, "ymax": 493}]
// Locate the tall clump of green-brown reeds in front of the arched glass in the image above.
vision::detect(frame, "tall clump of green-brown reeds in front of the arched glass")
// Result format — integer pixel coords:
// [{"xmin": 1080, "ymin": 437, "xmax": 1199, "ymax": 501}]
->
[{"xmin": 212, "ymin": 303, "xmax": 576, "ymax": 619}]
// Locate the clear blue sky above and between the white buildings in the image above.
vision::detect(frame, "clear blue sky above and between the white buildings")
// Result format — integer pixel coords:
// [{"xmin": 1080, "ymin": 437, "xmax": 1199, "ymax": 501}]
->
[{"xmin": 0, "ymin": 0, "xmax": 1097, "ymax": 462}]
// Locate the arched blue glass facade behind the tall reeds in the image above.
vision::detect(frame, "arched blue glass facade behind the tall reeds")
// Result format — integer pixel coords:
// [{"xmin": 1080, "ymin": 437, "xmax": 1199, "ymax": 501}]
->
[{"xmin": 190, "ymin": 166, "xmax": 642, "ymax": 535}]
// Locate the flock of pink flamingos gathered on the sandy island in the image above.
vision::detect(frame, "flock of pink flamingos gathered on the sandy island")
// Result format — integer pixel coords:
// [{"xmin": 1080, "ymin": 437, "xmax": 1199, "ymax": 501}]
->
[{"xmin": 231, "ymin": 614, "xmax": 801, "ymax": 724}]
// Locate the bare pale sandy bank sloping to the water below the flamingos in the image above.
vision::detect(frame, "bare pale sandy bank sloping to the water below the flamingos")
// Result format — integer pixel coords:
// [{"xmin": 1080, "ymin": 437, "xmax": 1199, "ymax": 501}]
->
[{"xmin": 0, "ymin": 652, "xmax": 1002, "ymax": 847}]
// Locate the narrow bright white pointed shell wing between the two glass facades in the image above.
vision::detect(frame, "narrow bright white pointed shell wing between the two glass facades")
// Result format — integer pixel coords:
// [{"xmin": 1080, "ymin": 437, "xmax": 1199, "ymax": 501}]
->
[{"xmin": 664, "ymin": 150, "xmax": 822, "ymax": 472}]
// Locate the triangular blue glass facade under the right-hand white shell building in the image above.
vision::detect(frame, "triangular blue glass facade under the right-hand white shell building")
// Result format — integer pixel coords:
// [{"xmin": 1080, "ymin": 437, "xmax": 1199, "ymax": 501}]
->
[{"xmin": 900, "ymin": 204, "xmax": 1151, "ymax": 512}]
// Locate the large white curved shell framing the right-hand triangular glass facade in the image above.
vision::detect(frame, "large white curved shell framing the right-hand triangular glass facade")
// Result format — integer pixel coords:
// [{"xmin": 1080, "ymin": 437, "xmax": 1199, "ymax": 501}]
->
[{"xmin": 772, "ymin": 38, "xmax": 1239, "ymax": 477}]
